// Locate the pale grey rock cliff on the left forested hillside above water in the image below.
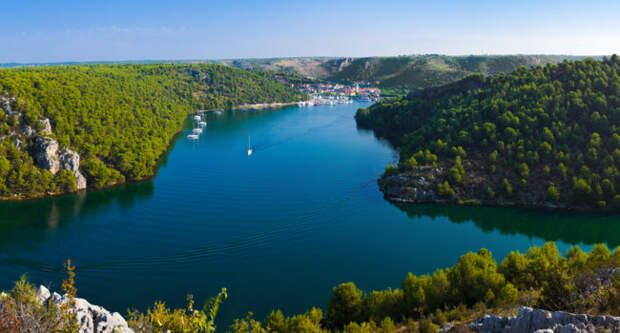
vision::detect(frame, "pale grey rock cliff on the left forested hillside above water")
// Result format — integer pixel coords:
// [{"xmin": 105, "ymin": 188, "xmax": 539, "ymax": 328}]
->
[{"xmin": 33, "ymin": 137, "xmax": 86, "ymax": 190}]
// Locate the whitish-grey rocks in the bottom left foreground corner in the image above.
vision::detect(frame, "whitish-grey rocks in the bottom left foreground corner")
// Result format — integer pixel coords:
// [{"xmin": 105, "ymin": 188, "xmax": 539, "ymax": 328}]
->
[{"xmin": 37, "ymin": 286, "xmax": 134, "ymax": 333}]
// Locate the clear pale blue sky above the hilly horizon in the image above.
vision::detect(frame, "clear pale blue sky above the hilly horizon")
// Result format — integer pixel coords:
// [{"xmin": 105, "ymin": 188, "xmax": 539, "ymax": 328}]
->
[{"xmin": 0, "ymin": 0, "xmax": 620, "ymax": 62}]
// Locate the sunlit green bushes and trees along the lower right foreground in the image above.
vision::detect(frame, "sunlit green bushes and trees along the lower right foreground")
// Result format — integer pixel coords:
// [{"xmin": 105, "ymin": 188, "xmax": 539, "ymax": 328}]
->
[{"xmin": 231, "ymin": 243, "xmax": 620, "ymax": 333}]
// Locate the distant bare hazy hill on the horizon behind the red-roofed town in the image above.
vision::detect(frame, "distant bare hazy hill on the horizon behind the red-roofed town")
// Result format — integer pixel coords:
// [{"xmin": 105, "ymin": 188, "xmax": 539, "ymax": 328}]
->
[{"xmin": 216, "ymin": 55, "xmax": 583, "ymax": 89}]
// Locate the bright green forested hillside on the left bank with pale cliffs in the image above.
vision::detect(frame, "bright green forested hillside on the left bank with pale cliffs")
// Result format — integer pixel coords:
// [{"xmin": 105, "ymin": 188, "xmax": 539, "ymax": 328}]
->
[{"xmin": 0, "ymin": 64, "xmax": 302, "ymax": 198}]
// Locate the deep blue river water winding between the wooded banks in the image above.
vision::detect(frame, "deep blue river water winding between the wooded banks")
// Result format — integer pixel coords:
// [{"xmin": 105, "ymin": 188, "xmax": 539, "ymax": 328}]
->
[{"xmin": 0, "ymin": 104, "xmax": 620, "ymax": 328}]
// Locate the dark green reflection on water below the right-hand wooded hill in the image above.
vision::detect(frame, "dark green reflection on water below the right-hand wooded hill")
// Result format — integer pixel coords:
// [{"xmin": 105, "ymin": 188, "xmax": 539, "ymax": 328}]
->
[{"xmin": 394, "ymin": 204, "xmax": 620, "ymax": 248}]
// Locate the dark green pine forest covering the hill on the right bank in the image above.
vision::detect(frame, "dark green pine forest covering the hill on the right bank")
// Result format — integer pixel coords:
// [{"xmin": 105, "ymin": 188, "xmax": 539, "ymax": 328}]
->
[{"xmin": 355, "ymin": 55, "xmax": 620, "ymax": 211}]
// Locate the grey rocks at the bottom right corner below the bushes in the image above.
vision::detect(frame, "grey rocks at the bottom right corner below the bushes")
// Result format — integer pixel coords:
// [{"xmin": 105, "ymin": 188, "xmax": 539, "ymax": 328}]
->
[{"xmin": 470, "ymin": 307, "xmax": 620, "ymax": 333}]
